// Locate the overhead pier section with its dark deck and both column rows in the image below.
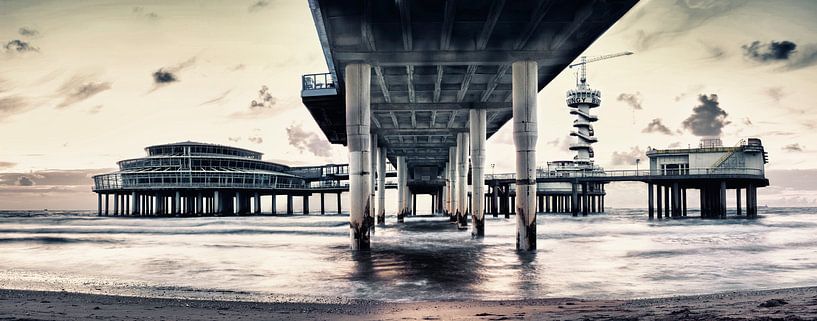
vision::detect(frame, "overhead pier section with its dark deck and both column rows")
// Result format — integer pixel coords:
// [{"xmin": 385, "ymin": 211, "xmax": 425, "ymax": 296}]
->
[{"xmin": 301, "ymin": 0, "xmax": 637, "ymax": 250}]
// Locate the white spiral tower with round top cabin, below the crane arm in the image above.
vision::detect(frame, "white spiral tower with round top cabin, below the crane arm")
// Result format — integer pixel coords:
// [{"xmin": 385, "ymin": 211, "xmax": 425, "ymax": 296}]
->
[{"xmin": 567, "ymin": 83, "xmax": 601, "ymax": 161}]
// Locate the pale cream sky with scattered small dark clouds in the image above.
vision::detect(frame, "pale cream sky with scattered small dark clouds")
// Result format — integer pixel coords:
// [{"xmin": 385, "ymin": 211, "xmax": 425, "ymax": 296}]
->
[{"xmin": 0, "ymin": 0, "xmax": 817, "ymax": 209}]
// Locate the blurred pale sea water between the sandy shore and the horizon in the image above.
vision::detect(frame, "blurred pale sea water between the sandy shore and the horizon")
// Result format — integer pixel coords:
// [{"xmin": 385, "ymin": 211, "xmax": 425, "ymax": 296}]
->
[{"xmin": 0, "ymin": 208, "xmax": 817, "ymax": 301}]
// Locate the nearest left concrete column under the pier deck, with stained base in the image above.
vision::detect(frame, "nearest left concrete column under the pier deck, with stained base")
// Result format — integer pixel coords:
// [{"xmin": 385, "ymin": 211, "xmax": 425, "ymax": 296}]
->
[{"xmin": 345, "ymin": 63, "xmax": 372, "ymax": 250}]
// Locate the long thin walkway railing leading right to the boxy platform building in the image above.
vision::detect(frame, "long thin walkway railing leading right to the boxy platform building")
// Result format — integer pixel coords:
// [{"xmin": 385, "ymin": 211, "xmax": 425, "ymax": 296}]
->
[{"xmin": 485, "ymin": 167, "xmax": 763, "ymax": 180}]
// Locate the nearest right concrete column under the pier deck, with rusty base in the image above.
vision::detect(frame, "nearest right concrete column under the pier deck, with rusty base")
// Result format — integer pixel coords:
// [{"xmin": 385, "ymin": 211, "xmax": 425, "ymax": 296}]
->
[{"xmin": 512, "ymin": 61, "xmax": 539, "ymax": 250}]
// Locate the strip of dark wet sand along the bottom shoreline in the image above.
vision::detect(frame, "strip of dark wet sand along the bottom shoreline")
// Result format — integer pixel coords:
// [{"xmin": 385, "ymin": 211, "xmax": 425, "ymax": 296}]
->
[{"xmin": 0, "ymin": 287, "xmax": 817, "ymax": 320}]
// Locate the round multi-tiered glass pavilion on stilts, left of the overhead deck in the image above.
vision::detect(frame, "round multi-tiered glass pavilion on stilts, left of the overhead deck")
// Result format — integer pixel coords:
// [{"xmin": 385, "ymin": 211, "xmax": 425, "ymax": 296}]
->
[{"xmin": 93, "ymin": 142, "xmax": 397, "ymax": 216}]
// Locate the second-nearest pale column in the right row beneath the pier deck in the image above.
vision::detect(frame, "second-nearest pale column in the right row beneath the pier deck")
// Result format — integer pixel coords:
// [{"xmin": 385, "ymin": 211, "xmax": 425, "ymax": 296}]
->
[{"xmin": 469, "ymin": 109, "xmax": 487, "ymax": 237}]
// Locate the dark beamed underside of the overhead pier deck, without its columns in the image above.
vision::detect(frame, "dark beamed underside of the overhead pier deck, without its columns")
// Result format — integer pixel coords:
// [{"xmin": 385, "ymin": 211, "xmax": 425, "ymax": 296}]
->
[{"xmin": 310, "ymin": 0, "xmax": 637, "ymax": 166}]
